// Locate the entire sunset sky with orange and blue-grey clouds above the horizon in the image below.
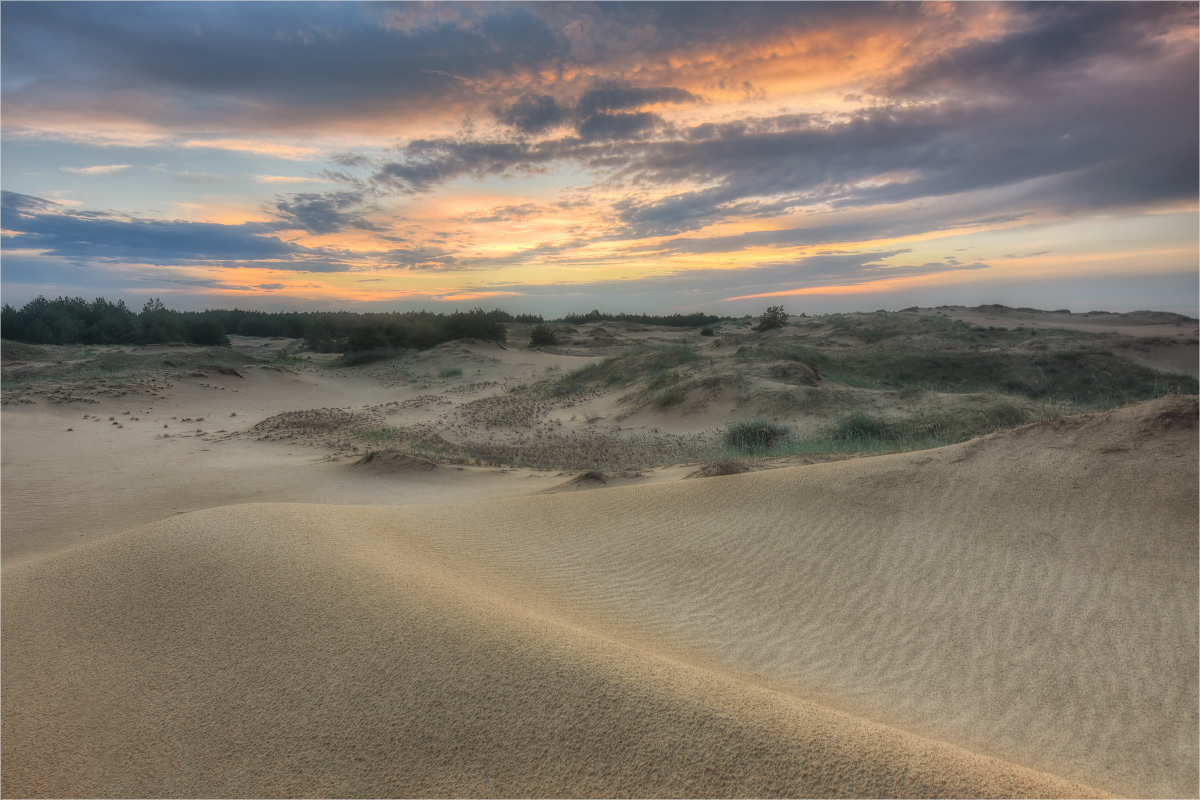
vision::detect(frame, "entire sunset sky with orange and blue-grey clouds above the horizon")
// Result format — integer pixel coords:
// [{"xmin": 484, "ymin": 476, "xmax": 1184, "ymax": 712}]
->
[{"xmin": 0, "ymin": 0, "xmax": 1200, "ymax": 317}]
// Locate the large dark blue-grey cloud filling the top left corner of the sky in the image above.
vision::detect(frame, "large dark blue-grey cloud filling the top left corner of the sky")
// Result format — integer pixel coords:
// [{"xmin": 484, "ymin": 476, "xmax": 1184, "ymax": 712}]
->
[{"xmin": 0, "ymin": 2, "xmax": 562, "ymax": 133}]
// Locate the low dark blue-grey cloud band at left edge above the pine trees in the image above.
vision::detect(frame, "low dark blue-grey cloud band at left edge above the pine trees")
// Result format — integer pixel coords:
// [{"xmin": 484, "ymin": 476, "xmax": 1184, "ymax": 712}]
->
[{"xmin": 0, "ymin": 192, "xmax": 348, "ymax": 271}]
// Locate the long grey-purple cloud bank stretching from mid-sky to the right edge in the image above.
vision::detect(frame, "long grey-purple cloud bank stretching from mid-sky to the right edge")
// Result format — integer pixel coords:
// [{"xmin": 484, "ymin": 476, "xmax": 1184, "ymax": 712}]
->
[{"xmin": 357, "ymin": 38, "xmax": 1200, "ymax": 237}]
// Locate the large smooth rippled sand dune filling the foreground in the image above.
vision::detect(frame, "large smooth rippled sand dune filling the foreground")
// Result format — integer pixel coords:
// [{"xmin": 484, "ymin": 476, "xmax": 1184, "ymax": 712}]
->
[{"xmin": 2, "ymin": 398, "xmax": 1200, "ymax": 796}]
